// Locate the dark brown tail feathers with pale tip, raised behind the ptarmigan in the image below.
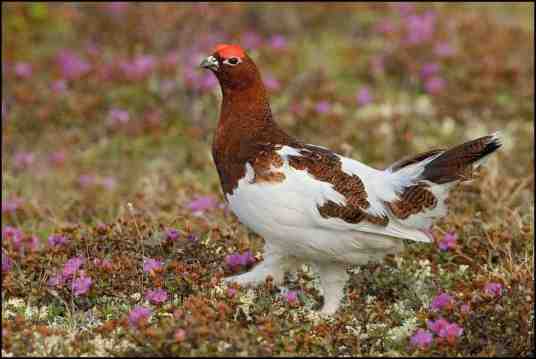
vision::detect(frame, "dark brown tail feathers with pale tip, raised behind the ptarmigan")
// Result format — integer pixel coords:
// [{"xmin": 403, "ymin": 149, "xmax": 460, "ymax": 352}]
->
[{"xmin": 421, "ymin": 134, "xmax": 501, "ymax": 184}]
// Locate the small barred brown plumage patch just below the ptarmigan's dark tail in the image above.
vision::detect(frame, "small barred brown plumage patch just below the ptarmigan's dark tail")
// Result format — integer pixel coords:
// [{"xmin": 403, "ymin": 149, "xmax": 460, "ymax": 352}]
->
[{"xmin": 387, "ymin": 183, "xmax": 437, "ymax": 219}]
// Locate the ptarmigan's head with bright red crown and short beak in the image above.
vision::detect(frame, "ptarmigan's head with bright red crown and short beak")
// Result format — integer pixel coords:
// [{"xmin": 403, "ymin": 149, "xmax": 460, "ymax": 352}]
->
[{"xmin": 200, "ymin": 44, "xmax": 262, "ymax": 91}]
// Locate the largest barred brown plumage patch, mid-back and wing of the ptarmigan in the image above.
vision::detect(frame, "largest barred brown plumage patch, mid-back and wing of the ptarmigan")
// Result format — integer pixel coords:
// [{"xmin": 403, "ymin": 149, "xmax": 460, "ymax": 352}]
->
[{"xmin": 288, "ymin": 145, "xmax": 389, "ymax": 226}]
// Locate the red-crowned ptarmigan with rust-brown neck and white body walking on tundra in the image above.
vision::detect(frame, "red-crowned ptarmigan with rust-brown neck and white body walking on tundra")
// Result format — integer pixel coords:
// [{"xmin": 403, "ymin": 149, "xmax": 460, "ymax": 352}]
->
[{"xmin": 200, "ymin": 44, "xmax": 501, "ymax": 316}]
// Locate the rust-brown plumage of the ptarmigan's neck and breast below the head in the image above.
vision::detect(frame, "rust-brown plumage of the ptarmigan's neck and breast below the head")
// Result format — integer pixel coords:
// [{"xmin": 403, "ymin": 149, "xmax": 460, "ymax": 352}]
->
[{"xmin": 212, "ymin": 58, "xmax": 292, "ymax": 194}]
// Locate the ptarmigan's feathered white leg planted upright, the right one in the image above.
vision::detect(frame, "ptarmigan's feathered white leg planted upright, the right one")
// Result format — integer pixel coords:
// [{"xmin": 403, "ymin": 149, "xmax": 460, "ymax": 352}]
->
[{"xmin": 316, "ymin": 263, "xmax": 350, "ymax": 315}]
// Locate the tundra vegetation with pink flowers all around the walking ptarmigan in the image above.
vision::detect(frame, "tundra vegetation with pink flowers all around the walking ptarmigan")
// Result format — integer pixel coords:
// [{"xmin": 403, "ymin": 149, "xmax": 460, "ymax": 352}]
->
[{"xmin": 2, "ymin": 3, "xmax": 534, "ymax": 356}]
